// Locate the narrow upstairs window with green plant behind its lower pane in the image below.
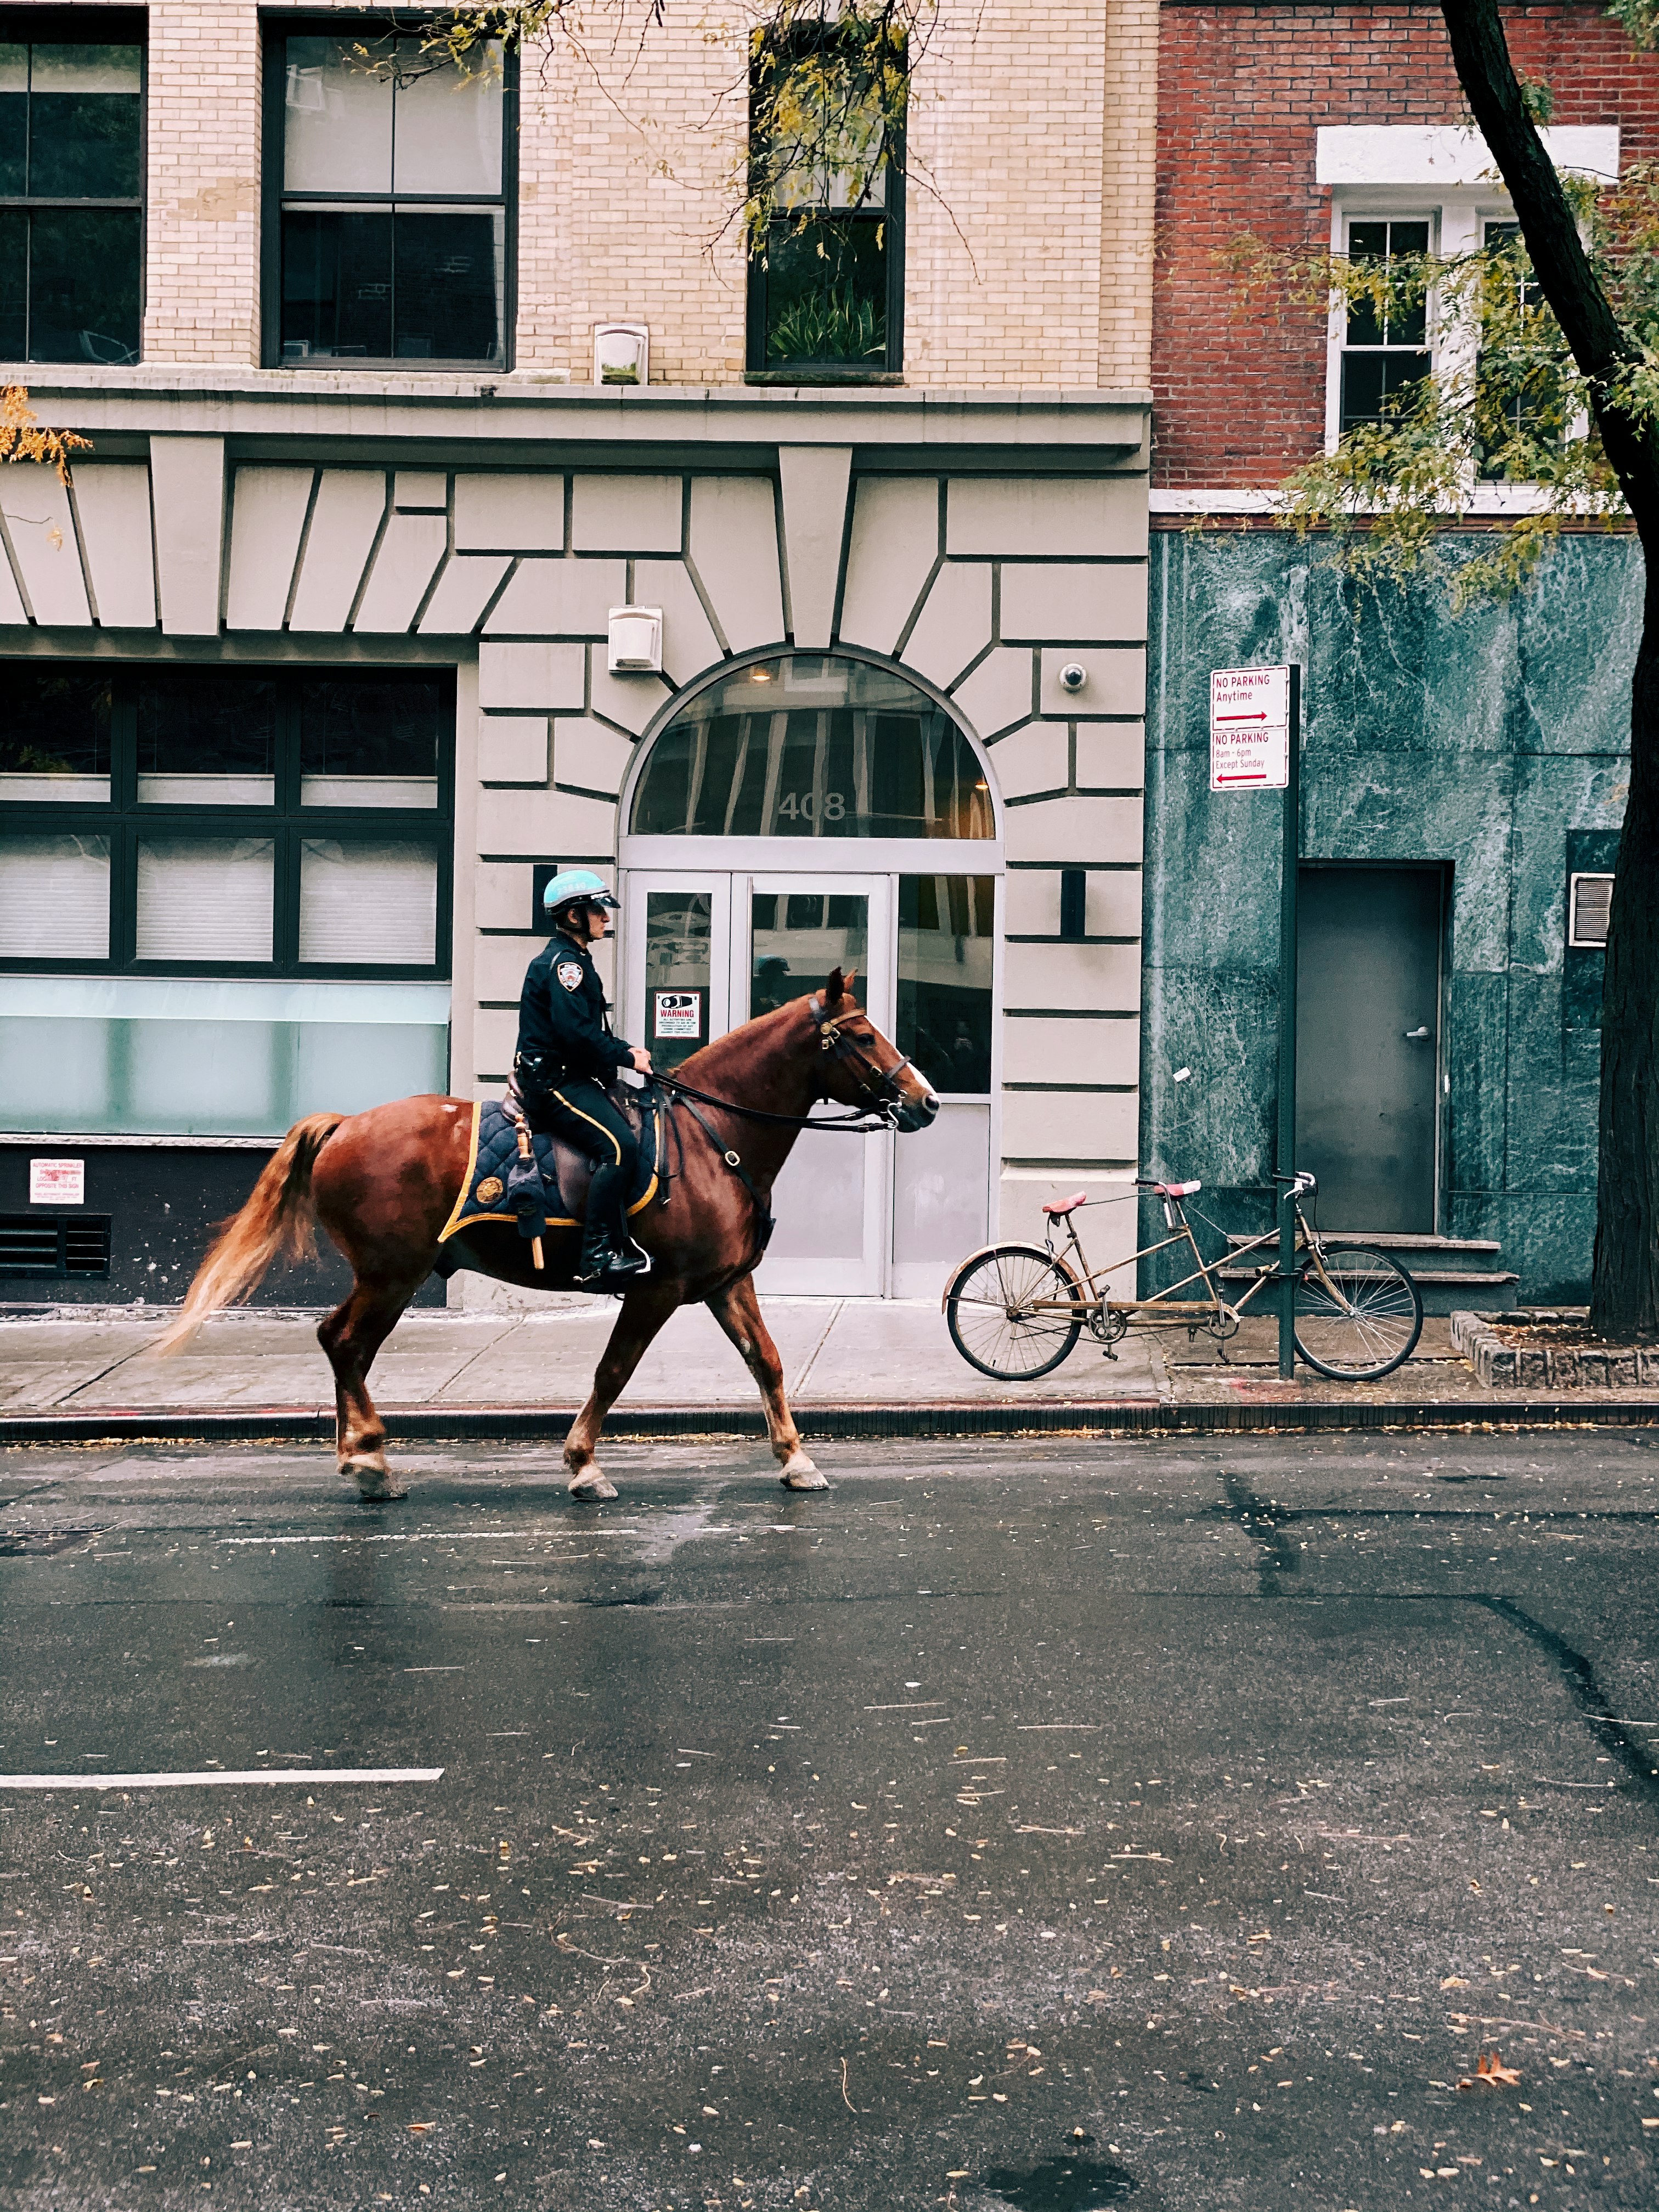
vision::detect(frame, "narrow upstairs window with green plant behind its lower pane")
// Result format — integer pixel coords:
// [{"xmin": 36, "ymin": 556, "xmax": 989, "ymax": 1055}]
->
[{"xmin": 748, "ymin": 24, "xmax": 905, "ymax": 383}]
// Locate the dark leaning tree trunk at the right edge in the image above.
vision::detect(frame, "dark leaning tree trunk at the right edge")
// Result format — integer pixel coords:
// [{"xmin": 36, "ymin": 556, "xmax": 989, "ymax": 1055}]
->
[{"xmin": 1440, "ymin": 0, "xmax": 1659, "ymax": 1342}]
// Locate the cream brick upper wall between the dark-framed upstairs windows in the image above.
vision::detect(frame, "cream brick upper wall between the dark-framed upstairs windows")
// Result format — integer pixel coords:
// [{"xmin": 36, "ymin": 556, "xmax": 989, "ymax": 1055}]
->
[{"xmin": 48, "ymin": 0, "xmax": 1157, "ymax": 390}]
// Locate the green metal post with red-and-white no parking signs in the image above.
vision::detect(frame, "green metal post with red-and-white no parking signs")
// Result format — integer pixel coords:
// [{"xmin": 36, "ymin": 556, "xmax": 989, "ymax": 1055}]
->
[{"xmin": 1210, "ymin": 664, "xmax": 1303, "ymax": 1380}]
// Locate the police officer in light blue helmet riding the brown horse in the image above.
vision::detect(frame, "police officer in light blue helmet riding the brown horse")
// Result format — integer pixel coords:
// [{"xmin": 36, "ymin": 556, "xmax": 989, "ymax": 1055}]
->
[{"xmin": 513, "ymin": 867, "xmax": 650, "ymax": 1290}]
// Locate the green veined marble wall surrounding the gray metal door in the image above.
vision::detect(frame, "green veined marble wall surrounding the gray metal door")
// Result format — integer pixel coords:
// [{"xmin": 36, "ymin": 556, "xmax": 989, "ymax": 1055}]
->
[{"xmin": 1142, "ymin": 531, "xmax": 1641, "ymax": 1301}]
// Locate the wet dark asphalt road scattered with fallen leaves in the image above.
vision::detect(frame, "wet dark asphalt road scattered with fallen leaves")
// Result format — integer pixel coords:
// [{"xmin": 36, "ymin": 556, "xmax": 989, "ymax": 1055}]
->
[{"xmin": 0, "ymin": 1434, "xmax": 1659, "ymax": 2212}]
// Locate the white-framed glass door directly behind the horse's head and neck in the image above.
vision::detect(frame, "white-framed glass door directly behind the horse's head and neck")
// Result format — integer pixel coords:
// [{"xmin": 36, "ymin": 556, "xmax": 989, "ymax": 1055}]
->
[{"xmin": 747, "ymin": 874, "xmax": 894, "ymax": 1299}]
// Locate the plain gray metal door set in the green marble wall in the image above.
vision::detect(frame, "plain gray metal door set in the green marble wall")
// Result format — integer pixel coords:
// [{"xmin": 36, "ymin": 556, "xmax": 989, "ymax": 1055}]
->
[{"xmin": 1296, "ymin": 867, "xmax": 1442, "ymax": 1234}]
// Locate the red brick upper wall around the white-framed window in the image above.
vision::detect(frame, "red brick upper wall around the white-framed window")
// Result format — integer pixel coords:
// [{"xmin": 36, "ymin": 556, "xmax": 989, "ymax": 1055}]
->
[{"xmin": 1153, "ymin": 0, "xmax": 1659, "ymax": 489}]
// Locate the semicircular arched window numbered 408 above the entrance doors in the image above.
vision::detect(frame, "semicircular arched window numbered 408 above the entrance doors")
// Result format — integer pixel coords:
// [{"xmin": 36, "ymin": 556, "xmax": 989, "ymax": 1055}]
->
[{"xmin": 633, "ymin": 652, "xmax": 995, "ymax": 838}]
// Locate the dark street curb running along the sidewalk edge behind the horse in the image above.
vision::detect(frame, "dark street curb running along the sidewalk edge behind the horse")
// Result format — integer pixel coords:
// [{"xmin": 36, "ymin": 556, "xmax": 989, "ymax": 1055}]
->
[{"xmin": 0, "ymin": 1398, "xmax": 1659, "ymax": 1444}]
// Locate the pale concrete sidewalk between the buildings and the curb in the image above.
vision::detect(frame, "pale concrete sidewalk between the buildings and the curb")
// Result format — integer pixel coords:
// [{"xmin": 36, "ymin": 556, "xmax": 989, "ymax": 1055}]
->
[{"xmin": 0, "ymin": 1299, "xmax": 1522, "ymax": 1418}]
